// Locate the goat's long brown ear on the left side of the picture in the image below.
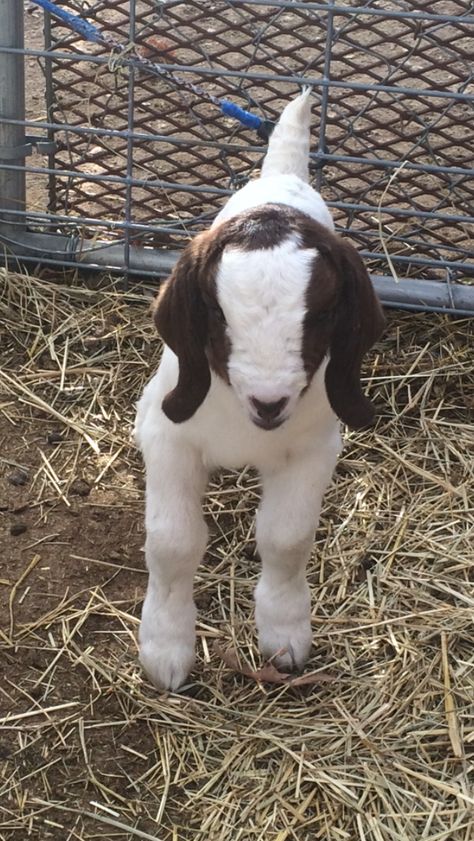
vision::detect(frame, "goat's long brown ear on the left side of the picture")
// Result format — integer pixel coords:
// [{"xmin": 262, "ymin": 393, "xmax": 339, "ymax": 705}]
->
[{"xmin": 154, "ymin": 242, "xmax": 211, "ymax": 423}]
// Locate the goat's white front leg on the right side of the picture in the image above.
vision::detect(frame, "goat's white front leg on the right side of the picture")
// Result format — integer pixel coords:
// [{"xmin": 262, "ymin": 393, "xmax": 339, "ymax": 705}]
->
[{"xmin": 255, "ymin": 435, "xmax": 340, "ymax": 669}]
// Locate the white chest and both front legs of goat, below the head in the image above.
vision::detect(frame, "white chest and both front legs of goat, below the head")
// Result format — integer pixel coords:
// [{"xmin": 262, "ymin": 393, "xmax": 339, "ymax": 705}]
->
[{"xmin": 136, "ymin": 364, "xmax": 341, "ymax": 689}]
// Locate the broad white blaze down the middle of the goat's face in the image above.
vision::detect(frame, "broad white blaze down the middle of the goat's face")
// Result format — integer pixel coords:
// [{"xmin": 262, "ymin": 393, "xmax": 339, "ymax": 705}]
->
[{"xmin": 217, "ymin": 236, "xmax": 317, "ymax": 416}]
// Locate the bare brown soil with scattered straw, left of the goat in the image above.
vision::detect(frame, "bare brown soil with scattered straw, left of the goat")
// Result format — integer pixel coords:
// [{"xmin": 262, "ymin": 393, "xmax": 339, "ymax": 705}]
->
[{"xmin": 0, "ymin": 380, "xmax": 155, "ymax": 841}]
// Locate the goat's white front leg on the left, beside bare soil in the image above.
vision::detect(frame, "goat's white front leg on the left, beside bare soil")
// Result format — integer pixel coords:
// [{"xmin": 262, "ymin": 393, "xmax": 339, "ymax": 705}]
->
[{"xmin": 139, "ymin": 435, "xmax": 207, "ymax": 689}]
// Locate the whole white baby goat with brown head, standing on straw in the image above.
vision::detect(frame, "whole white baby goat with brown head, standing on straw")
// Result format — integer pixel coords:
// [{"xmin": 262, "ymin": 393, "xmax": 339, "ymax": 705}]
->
[{"xmin": 135, "ymin": 91, "xmax": 384, "ymax": 689}]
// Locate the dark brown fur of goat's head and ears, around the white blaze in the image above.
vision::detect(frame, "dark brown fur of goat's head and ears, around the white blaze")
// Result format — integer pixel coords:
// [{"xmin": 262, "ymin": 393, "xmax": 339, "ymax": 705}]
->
[{"xmin": 155, "ymin": 204, "xmax": 385, "ymax": 428}]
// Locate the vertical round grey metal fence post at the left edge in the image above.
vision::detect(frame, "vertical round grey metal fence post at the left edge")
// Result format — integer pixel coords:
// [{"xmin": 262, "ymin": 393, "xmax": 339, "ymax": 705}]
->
[{"xmin": 0, "ymin": 0, "xmax": 26, "ymax": 231}]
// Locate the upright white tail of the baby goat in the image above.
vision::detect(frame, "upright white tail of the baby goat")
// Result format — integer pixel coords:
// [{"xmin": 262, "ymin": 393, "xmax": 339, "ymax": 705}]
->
[{"xmin": 261, "ymin": 87, "xmax": 311, "ymax": 181}]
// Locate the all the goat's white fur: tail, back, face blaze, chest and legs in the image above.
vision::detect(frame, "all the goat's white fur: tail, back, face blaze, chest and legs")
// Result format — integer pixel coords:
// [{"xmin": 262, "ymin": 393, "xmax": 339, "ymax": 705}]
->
[{"xmin": 135, "ymin": 94, "xmax": 341, "ymax": 689}]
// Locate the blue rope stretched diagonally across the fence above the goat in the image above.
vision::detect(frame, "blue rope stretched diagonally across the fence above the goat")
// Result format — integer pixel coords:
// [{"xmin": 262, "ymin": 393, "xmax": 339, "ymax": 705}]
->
[{"xmin": 32, "ymin": 0, "xmax": 274, "ymax": 140}]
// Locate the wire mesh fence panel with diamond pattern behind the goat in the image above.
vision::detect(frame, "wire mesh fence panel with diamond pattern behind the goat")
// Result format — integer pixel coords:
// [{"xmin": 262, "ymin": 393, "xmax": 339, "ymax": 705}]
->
[{"xmin": 0, "ymin": 0, "xmax": 474, "ymax": 306}]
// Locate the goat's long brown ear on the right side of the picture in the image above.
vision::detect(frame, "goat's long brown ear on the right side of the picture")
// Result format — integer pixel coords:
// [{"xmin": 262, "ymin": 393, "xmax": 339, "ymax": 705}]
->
[{"xmin": 325, "ymin": 242, "xmax": 385, "ymax": 429}]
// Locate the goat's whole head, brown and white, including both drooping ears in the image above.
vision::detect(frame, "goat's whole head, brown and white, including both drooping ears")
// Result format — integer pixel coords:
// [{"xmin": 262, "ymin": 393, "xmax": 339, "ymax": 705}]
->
[{"xmin": 155, "ymin": 204, "xmax": 384, "ymax": 430}]
